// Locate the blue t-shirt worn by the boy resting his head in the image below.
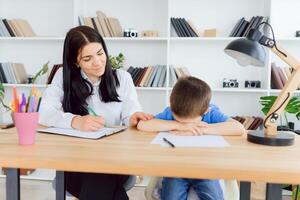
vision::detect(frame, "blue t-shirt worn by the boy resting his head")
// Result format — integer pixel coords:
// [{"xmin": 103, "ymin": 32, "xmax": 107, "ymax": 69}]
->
[{"xmin": 155, "ymin": 104, "xmax": 229, "ymax": 124}]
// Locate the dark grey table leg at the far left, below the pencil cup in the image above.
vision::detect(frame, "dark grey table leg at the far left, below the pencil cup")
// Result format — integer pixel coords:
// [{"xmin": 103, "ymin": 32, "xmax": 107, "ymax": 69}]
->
[{"xmin": 6, "ymin": 168, "xmax": 20, "ymax": 200}]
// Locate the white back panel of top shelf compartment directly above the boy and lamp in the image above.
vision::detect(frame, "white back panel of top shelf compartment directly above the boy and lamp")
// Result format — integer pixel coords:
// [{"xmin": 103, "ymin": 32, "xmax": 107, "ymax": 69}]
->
[{"xmin": 170, "ymin": 0, "xmax": 269, "ymax": 37}]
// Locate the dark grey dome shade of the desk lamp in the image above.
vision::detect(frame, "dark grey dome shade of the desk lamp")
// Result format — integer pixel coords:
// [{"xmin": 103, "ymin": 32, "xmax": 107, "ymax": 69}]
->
[{"xmin": 224, "ymin": 38, "xmax": 266, "ymax": 67}]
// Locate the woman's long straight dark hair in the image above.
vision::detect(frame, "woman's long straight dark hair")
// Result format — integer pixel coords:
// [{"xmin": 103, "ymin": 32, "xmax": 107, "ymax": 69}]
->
[{"xmin": 62, "ymin": 26, "xmax": 120, "ymax": 115}]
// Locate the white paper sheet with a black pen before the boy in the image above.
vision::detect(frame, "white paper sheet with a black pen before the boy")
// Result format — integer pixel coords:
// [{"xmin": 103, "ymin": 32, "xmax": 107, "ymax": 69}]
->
[{"xmin": 151, "ymin": 132, "xmax": 230, "ymax": 148}]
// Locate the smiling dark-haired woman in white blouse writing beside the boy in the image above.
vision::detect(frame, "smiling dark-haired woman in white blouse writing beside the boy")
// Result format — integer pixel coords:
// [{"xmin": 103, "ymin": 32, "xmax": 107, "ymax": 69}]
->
[{"xmin": 40, "ymin": 26, "xmax": 152, "ymax": 200}]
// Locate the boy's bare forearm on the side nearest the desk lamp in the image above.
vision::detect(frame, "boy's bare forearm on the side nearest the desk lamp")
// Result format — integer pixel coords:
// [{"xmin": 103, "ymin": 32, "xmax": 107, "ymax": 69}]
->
[{"xmin": 202, "ymin": 119, "xmax": 246, "ymax": 135}]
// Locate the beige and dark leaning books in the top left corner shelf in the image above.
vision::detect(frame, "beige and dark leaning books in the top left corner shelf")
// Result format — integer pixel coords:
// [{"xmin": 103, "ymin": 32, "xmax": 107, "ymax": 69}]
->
[{"xmin": 0, "ymin": 18, "xmax": 36, "ymax": 37}]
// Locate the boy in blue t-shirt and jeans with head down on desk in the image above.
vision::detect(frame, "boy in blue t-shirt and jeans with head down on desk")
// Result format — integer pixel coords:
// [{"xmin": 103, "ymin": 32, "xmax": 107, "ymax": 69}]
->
[{"xmin": 137, "ymin": 76, "xmax": 245, "ymax": 200}]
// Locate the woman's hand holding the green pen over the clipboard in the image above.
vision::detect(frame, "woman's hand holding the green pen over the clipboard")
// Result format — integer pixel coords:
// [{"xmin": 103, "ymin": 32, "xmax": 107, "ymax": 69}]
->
[{"xmin": 71, "ymin": 115, "xmax": 105, "ymax": 131}]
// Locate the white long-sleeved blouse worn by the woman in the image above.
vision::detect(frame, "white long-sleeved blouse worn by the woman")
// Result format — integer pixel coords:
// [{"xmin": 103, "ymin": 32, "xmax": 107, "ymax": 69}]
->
[{"xmin": 39, "ymin": 69, "xmax": 142, "ymax": 128}]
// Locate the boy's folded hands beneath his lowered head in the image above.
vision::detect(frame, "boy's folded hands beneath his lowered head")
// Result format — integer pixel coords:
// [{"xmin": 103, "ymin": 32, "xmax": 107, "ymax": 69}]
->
[{"xmin": 171, "ymin": 121, "xmax": 207, "ymax": 136}]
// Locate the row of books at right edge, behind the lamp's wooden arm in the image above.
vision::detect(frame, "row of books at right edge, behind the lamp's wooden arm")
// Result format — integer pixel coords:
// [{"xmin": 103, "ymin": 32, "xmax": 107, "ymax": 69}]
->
[{"xmin": 271, "ymin": 62, "xmax": 300, "ymax": 89}]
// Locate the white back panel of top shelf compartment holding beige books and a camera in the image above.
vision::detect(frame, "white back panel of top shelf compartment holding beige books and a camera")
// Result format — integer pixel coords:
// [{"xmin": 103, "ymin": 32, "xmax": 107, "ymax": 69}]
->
[{"xmin": 81, "ymin": 0, "xmax": 168, "ymax": 37}]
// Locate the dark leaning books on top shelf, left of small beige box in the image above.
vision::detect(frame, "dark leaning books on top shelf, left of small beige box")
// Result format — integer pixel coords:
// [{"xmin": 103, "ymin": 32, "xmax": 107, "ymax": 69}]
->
[{"xmin": 171, "ymin": 17, "xmax": 200, "ymax": 37}]
